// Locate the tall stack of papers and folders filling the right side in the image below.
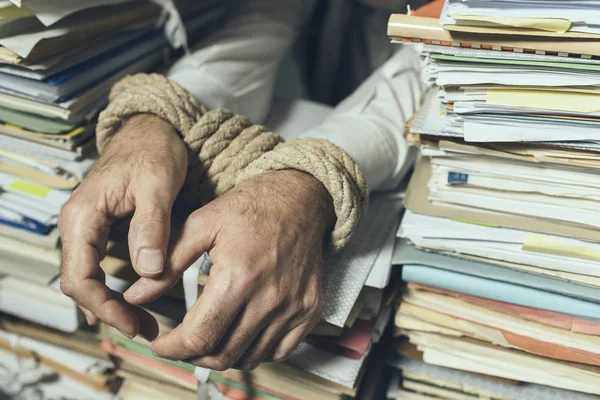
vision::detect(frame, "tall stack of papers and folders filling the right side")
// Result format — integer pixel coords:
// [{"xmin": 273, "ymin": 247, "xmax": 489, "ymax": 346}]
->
[{"xmin": 389, "ymin": 0, "xmax": 600, "ymax": 399}]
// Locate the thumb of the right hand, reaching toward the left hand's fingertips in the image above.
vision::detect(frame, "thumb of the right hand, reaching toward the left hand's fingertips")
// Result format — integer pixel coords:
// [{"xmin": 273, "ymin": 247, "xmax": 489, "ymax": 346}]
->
[{"xmin": 124, "ymin": 207, "xmax": 215, "ymax": 304}]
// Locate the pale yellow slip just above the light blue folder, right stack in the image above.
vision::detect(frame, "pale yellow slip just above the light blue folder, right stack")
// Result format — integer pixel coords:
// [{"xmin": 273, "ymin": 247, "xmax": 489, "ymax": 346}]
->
[{"xmin": 523, "ymin": 232, "xmax": 600, "ymax": 261}]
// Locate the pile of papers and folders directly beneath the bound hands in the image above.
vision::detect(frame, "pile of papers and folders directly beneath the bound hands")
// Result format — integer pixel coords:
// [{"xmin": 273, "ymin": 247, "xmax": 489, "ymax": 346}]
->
[{"xmin": 101, "ymin": 195, "xmax": 401, "ymax": 400}]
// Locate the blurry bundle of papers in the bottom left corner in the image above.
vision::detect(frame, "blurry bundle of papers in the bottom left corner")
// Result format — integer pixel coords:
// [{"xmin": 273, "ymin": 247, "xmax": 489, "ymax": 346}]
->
[{"xmin": 0, "ymin": 317, "xmax": 118, "ymax": 400}]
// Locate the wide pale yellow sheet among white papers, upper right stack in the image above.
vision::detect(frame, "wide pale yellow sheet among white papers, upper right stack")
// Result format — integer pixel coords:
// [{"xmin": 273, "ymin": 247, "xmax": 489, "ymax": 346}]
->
[{"xmin": 486, "ymin": 89, "xmax": 600, "ymax": 113}]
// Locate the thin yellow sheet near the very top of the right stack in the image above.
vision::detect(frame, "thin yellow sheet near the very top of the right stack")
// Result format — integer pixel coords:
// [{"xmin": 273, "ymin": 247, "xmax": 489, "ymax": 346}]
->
[{"xmin": 452, "ymin": 14, "xmax": 571, "ymax": 33}]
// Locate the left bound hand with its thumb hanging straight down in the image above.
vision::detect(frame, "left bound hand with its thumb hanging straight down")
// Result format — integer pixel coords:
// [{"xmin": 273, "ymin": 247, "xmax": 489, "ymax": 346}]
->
[{"xmin": 59, "ymin": 115, "xmax": 188, "ymax": 340}]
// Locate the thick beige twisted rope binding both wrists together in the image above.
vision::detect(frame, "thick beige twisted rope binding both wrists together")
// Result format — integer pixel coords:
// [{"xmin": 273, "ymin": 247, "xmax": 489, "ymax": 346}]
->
[{"xmin": 96, "ymin": 74, "xmax": 369, "ymax": 249}]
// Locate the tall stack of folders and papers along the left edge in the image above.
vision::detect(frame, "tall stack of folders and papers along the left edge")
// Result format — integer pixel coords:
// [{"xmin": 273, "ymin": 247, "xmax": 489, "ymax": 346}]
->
[{"xmin": 0, "ymin": 0, "xmax": 226, "ymax": 399}]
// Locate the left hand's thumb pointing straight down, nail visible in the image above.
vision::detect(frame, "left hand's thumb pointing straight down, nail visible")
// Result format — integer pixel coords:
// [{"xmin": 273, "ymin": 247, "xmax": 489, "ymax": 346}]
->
[{"xmin": 129, "ymin": 178, "xmax": 176, "ymax": 278}]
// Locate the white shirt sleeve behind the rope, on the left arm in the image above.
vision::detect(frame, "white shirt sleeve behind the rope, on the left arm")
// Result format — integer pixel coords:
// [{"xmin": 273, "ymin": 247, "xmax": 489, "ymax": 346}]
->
[{"xmin": 167, "ymin": 0, "xmax": 314, "ymax": 123}]
